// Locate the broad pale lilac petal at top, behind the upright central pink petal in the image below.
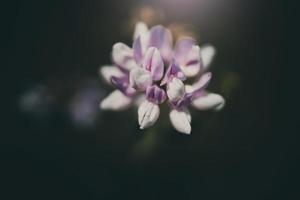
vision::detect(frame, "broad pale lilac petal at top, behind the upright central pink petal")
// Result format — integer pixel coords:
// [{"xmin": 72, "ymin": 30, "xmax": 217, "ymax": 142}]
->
[{"xmin": 148, "ymin": 25, "xmax": 172, "ymax": 61}]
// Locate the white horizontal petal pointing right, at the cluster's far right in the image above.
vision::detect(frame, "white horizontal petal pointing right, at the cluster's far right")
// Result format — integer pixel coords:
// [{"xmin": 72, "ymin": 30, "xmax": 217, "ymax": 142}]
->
[{"xmin": 192, "ymin": 93, "xmax": 225, "ymax": 111}]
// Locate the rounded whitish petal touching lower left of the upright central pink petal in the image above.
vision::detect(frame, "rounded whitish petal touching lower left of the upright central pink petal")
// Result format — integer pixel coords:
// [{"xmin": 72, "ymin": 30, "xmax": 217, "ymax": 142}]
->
[{"xmin": 129, "ymin": 67, "xmax": 152, "ymax": 91}]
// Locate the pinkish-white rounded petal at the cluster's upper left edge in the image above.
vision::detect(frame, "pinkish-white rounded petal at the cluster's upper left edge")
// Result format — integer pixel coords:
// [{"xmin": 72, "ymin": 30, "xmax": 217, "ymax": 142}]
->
[{"xmin": 112, "ymin": 42, "xmax": 137, "ymax": 70}]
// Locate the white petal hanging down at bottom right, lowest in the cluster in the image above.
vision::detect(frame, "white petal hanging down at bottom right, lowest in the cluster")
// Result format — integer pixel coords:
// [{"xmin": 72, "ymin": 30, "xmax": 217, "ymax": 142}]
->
[{"xmin": 170, "ymin": 109, "xmax": 192, "ymax": 134}]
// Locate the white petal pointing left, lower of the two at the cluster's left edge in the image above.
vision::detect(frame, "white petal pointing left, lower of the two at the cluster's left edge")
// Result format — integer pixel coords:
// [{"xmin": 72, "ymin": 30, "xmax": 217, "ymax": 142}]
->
[{"xmin": 100, "ymin": 90, "xmax": 132, "ymax": 111}]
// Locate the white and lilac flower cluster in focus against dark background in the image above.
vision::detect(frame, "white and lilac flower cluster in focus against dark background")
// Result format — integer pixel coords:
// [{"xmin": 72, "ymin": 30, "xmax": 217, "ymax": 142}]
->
[{"xmin": 100, "ymin": 22, "xmax": 225, "ymax": 134}]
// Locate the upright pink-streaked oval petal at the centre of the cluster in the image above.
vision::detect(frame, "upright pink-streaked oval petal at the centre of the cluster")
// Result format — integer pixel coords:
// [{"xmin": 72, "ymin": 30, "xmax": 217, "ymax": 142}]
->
[{"xmin": 143, "ymin": 47, "xmax": 164, "ymax": 81}]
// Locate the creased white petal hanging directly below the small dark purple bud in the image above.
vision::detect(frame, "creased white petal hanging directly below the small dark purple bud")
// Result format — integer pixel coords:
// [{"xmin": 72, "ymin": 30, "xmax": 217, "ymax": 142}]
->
[{"xmin": 138, "ymin": 100, "xmax": 159, "ymax": 129}]
